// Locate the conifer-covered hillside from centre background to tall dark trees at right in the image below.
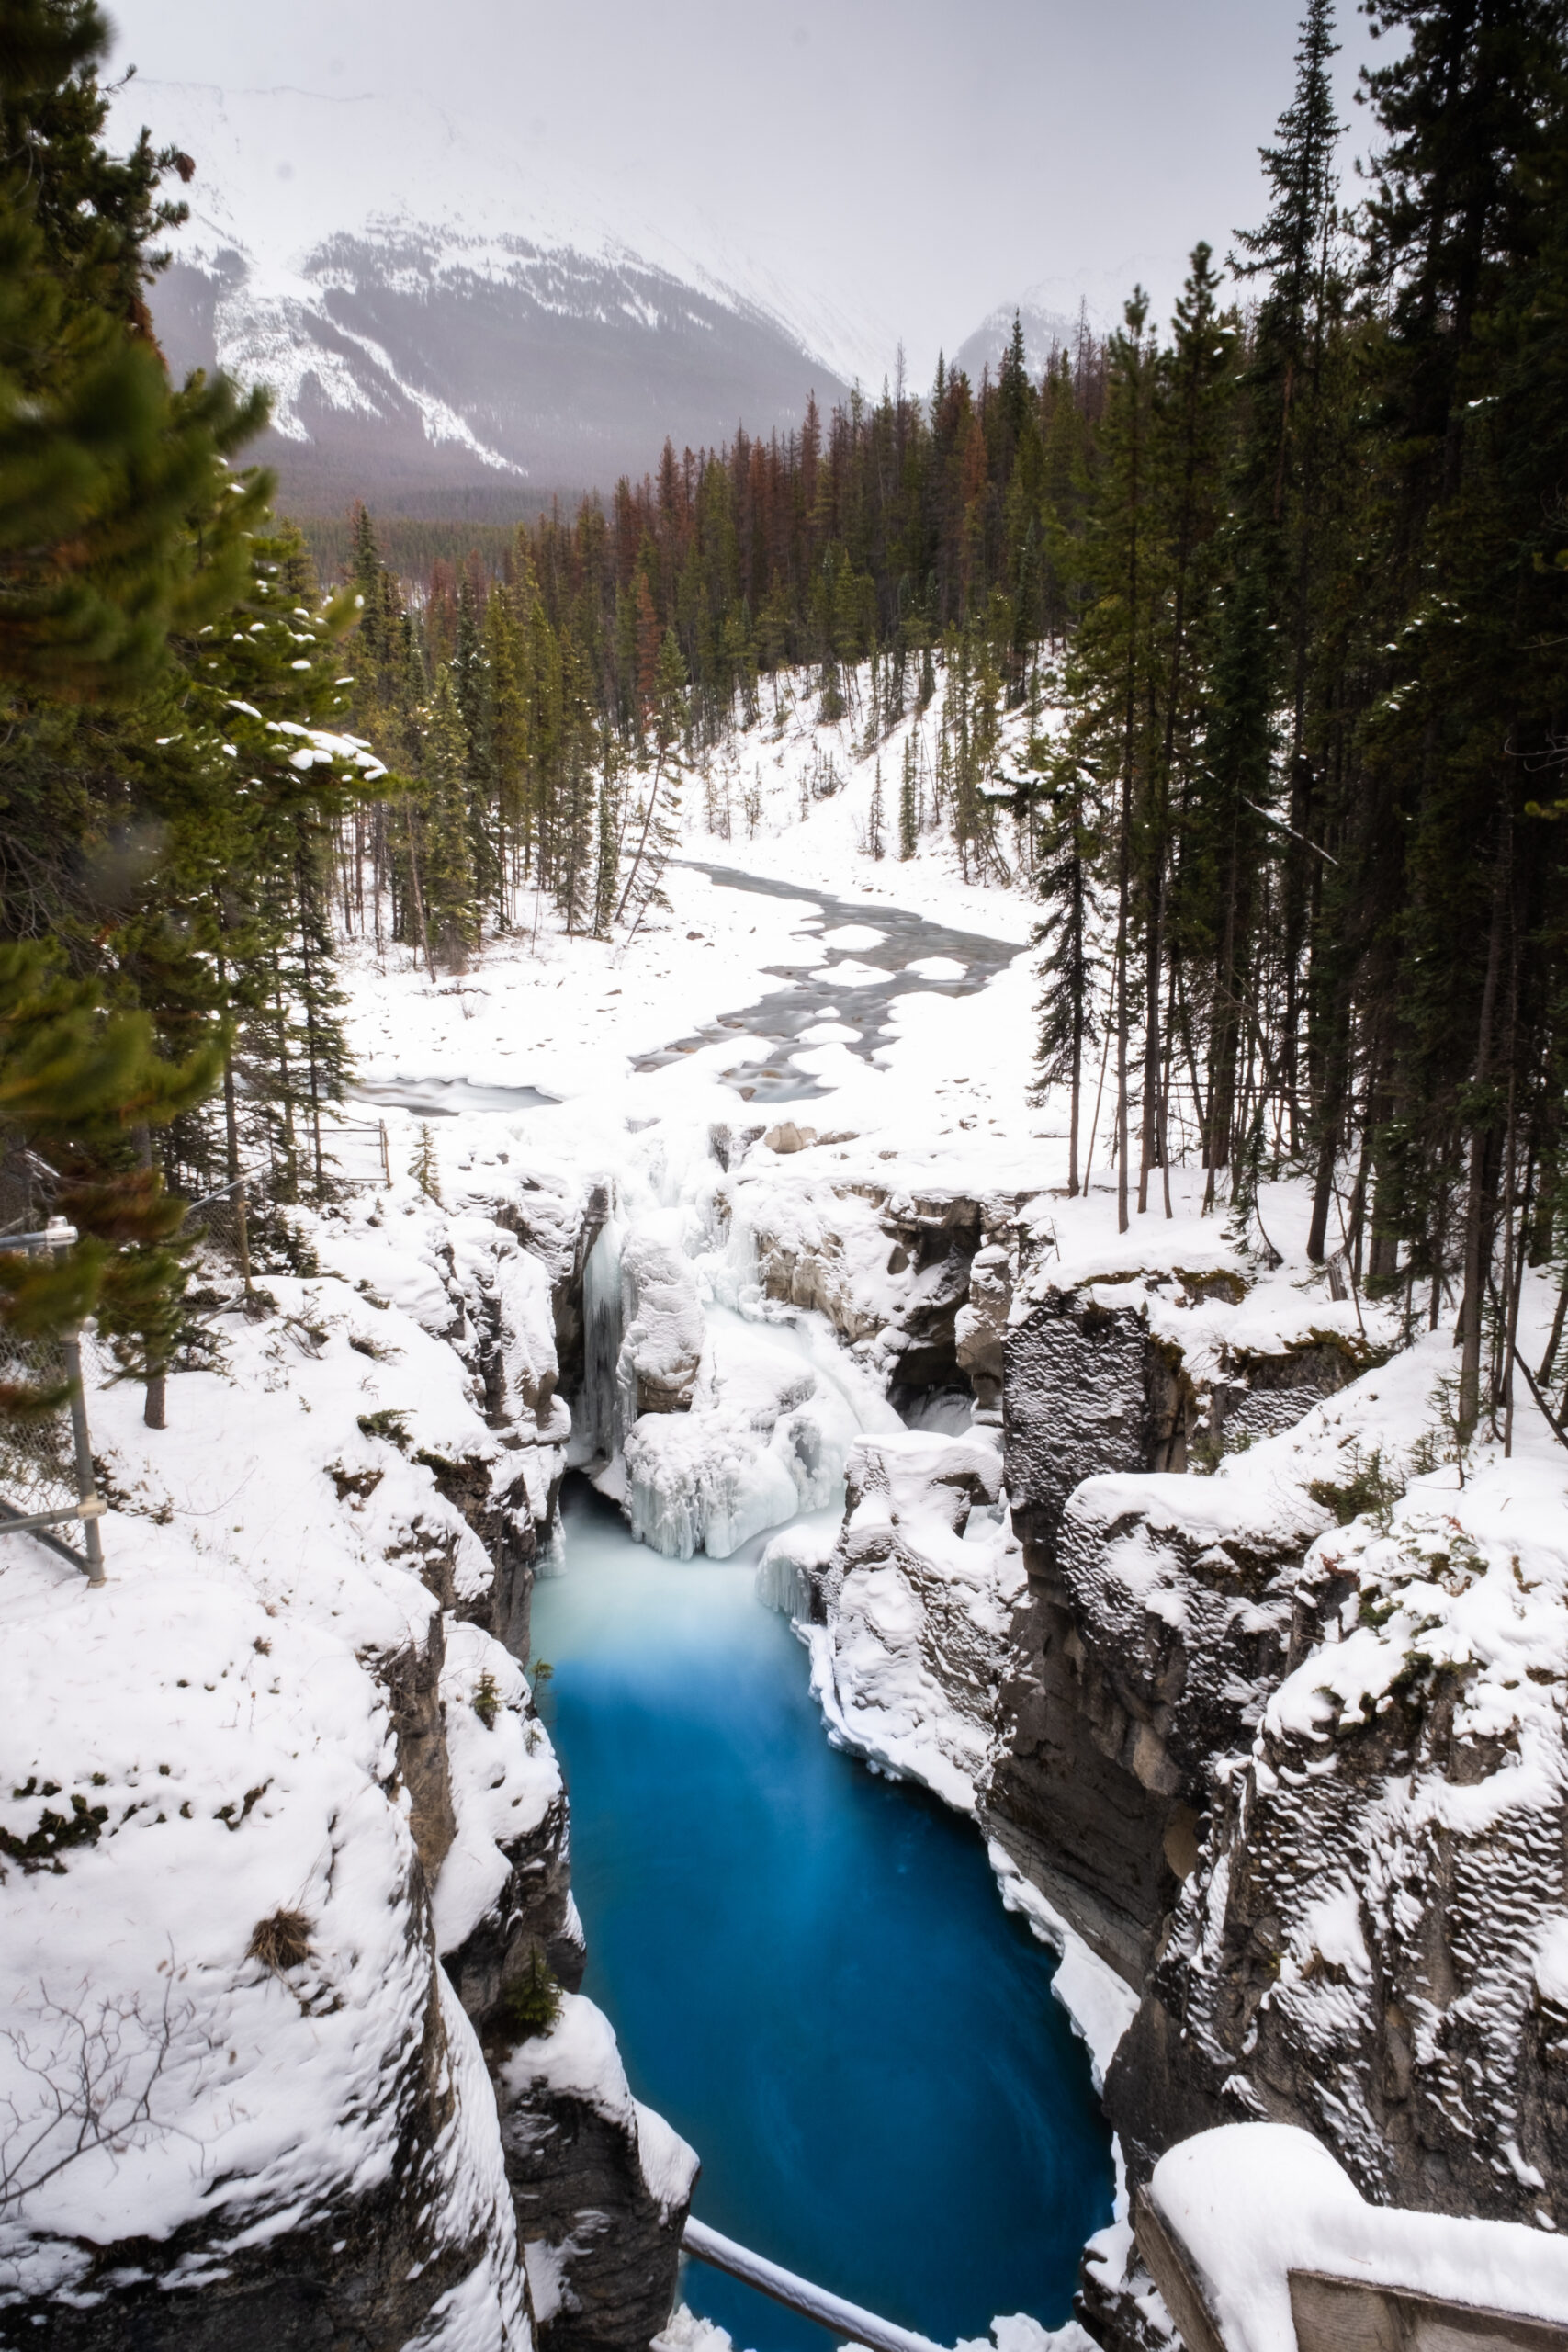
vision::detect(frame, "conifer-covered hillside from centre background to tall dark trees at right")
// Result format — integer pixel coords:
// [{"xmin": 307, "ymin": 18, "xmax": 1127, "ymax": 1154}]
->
[{"xmin": 341, "ymin": 0, "xmax": 1568, "ymax": 1425}]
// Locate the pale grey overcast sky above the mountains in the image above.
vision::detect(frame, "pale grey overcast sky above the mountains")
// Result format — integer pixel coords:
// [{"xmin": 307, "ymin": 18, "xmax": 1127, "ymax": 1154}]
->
[{"xmin": 110, "ymin": 0, "xmax": 1368, "ymax": 381}]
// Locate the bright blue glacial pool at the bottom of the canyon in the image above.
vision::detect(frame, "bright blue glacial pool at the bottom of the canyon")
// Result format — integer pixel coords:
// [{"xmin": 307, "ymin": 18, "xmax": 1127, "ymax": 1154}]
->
[{"xmin": 534, "ymin": 1479, "xmax": 1112, "ymax": 2352}]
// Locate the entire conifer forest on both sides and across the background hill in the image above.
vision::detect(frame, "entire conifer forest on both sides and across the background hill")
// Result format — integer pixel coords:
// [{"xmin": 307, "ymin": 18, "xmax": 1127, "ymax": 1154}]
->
[{"xmin": 0, "ymin": 0, "xmax": 1568, "ymax": 1467}]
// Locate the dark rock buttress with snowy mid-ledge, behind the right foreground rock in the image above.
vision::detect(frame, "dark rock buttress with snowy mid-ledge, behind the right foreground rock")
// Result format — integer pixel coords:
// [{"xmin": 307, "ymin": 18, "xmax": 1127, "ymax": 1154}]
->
[{"xmin": 983, "ymin": 1275, "xmax": 1349, "ymax": 1985}]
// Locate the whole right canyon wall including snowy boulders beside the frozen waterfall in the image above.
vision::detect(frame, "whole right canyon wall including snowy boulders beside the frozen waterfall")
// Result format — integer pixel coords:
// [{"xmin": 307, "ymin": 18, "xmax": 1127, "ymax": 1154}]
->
[{"xmin": 740, "ymin": 1162, "xmax": 1568, "ymax": 2352}]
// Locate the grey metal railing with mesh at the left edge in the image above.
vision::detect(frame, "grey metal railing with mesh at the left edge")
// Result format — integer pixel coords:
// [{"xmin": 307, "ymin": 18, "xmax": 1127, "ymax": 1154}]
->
[{"xmin": 0, "ymin": 1218, "xmax": 106, "ymax": 1585}]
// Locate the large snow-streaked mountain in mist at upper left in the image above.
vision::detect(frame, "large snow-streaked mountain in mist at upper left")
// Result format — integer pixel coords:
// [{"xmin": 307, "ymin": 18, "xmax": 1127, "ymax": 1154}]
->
[{"xmin": 115, "ymin": 80, "xmax": 870, "ymax": 511}]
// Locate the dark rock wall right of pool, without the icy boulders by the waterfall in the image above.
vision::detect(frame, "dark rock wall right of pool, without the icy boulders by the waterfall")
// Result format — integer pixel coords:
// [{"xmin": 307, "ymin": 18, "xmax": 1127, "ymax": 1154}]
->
[{"xmin": 980, "ymin": 1275, "xmax": 1568, "ymax": 2352}]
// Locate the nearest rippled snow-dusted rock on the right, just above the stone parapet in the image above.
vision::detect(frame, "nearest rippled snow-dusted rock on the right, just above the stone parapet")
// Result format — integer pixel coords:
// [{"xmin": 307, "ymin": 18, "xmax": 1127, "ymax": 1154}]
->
[{"xmin": 1107, "ymin": 1494, "xmax": 1568, "ymax": 2227}]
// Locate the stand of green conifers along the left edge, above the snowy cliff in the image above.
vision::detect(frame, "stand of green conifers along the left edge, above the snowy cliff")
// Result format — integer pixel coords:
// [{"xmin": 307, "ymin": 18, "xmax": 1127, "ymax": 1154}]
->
[{"xmin": 0, "ymin": 0, "xmax": 383, "ymax": 1425}]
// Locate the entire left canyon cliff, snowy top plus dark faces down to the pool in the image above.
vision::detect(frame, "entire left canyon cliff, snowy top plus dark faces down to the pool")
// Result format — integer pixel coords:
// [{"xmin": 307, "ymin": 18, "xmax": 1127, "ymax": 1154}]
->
[{"xmin": 0, "ymin": 1183, "xmax": 696, "ymax": 2352}]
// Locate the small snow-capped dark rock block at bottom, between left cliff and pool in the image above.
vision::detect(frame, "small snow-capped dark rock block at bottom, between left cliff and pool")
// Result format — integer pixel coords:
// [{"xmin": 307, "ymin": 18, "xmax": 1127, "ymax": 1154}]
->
[{"xmin": 499, "ymin": 1995, "xmax": 698, "ymax": 2352}]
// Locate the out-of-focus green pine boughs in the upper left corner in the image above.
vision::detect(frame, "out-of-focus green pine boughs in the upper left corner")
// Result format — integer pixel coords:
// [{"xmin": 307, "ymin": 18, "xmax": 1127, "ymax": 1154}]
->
[{"xmin": 0, "ymin": 0, "xmax": 270, "ymax": 701}]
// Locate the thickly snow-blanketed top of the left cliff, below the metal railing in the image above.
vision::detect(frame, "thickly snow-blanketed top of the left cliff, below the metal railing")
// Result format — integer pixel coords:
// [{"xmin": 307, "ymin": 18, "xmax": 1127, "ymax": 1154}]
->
[{"xmin": 0, "ymin": 1277, "xmax": 526, "ymax": 2352}]
